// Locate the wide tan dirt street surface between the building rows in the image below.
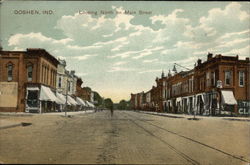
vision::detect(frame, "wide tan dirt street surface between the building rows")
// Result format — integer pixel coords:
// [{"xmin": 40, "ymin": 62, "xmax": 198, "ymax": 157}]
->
[{"xmin": 0, "ymin": 111, "xmax": 250, "ymax": 165}]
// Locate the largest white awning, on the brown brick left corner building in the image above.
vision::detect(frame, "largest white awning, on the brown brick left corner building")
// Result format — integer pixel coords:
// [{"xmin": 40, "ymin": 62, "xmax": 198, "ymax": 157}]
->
[{"xmin": 40, "ymin": 86, "xmax": 61, "ymax": 104}]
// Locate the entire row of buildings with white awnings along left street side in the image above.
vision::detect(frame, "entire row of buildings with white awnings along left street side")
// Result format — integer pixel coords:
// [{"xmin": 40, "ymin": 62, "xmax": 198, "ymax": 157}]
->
[{"xmin": 0, "ymin": 49, "xmax": 95, "ymax": 113}]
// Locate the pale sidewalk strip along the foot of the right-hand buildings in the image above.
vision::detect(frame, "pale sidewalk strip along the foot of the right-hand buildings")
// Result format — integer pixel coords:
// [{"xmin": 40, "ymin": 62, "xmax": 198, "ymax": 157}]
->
[{"xmin": 135, "ymin": 110, "xmax": 250, "ymax": 122}]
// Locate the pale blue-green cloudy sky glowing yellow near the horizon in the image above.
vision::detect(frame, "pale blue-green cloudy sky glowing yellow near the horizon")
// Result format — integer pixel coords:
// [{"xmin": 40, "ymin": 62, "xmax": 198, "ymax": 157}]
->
[{"xmin": 0, "ymin": 1, "xmax": 250, "ymax": 102}]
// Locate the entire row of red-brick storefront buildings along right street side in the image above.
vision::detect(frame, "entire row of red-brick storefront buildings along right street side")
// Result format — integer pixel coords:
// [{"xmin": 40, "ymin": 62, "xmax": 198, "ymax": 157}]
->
[{"xmin": 131, "ymin": 53, "xmax": 250, "ymax": 115}]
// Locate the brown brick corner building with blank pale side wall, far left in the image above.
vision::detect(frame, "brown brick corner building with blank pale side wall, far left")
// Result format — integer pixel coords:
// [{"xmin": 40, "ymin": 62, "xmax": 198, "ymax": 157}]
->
[{"xmin": 0, "ymin": 49, "xmax": 60, "ymax": 112}]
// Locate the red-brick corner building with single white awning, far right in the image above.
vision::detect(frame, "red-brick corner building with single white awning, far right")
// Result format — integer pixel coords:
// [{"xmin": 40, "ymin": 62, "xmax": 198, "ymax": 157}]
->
[{"xmin": 194, "ymin": 53, "xmax": 250, "ymax": 115}]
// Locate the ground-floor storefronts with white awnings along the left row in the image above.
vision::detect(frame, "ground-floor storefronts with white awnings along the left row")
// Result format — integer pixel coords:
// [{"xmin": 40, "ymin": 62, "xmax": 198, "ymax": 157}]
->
[{"xmin": 25, "ymin": 85, "xmax": 95, "ymax": 113}]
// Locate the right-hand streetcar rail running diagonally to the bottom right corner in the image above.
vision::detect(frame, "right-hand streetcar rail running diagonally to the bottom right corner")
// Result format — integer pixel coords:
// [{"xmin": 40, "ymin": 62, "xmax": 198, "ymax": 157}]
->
[{"xmin": 123, "ymin": 113, "xmax": 250, "ymax": 163}]
